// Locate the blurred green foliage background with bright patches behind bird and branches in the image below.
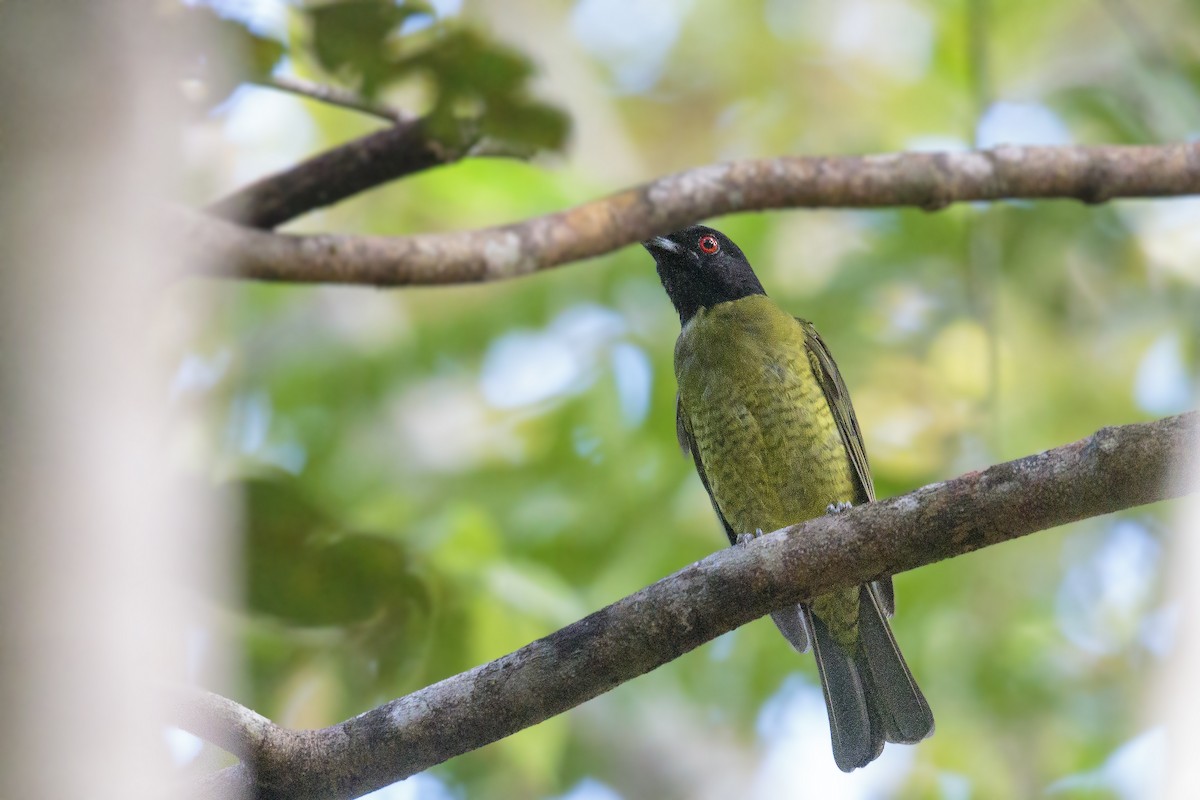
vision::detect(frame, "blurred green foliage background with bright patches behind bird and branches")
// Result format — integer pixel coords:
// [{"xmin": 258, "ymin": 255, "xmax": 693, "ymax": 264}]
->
[{"xmin": 172, "ymin": 0, "xmax": 1200, "ymax": 800}]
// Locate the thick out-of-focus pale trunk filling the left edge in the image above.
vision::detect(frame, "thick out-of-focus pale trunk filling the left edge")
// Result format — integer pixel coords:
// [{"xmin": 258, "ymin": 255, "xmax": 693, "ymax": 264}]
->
[{"xmin": 0, "ymin": 6, "xmax": 231, "ymax": 800}]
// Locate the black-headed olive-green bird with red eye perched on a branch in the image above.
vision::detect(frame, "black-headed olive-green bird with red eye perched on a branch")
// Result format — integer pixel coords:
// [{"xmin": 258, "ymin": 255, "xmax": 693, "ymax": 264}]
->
[{"xmin": 642, "ymin": 225, "xmax": 934, "ymax": 772}]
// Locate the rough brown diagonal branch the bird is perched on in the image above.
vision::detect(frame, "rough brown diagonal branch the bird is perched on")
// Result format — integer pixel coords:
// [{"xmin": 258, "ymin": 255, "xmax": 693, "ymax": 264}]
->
[{"xmin": 182, "ymin": 411, "xmax": 1200, "ymax": 798}]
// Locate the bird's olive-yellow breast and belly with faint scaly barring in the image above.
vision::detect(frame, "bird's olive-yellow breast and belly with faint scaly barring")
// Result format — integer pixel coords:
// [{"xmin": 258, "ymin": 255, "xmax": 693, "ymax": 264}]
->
[{"xmin": 676, "ymin": 295, "xmax": 856, "ymax": 542}]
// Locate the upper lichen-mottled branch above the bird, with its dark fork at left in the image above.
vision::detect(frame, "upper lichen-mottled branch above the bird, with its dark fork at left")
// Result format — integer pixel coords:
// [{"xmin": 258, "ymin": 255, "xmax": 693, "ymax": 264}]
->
[{"xmin": 184, "ymin": 143, "xmax": 1200, "ymax": 285}]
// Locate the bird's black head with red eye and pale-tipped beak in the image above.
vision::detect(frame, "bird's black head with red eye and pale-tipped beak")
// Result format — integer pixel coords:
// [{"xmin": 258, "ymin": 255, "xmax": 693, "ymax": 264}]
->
[{"xmin": 642, "ymin": 225, "xmax": 767, "ymax": 325}]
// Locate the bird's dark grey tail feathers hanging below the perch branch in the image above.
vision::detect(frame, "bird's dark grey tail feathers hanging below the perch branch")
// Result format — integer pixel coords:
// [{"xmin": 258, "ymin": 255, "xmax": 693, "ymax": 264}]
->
[{"xmin": 802, "ymin": 585, "xmax": 934, "ymax": 772}]
